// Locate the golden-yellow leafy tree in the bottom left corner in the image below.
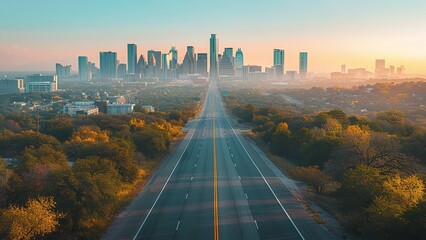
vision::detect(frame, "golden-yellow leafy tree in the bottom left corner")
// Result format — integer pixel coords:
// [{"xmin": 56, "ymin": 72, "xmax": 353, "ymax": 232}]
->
[{"xmin": 0, "ymin": 197, "xmax": 64, "ymax": 240}]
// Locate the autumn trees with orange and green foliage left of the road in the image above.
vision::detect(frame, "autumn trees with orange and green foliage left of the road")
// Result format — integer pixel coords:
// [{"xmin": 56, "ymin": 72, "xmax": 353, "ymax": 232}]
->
[{"xmin": 0, "ymin": 110, "xmax": 195, "ymax": 239}]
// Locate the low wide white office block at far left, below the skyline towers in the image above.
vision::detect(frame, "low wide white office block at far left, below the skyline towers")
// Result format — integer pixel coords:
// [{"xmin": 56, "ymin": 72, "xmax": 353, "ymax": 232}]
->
[{"xmin": 24, "ymin": 74, "xmax": 58, "ymax": 93}]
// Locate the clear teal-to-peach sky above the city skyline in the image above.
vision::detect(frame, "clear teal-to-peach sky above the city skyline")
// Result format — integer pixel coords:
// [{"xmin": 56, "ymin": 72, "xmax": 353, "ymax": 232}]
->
[{"xmin": 0, "ymin": 0, "xmax": 426, "ymax": 74}]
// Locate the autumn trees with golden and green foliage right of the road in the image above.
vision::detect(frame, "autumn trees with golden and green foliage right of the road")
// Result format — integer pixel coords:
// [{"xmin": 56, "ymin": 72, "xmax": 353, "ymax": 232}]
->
[{"xmin": 229, "ymin": 104, "xmax": 426, "ymax": 239}]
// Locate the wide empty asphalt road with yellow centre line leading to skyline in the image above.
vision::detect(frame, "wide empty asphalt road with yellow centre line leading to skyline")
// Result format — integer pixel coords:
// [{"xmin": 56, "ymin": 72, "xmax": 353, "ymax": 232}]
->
[{"xmin": 103, "ymin": 83, "xmax": 334, "ymax": 240}]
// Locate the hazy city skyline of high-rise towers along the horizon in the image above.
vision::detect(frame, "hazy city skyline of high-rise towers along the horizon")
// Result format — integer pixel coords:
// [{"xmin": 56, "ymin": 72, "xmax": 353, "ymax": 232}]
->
[{"xmin": 0, "ymin": 34, "xmax": 412, "ymax": 97}]
